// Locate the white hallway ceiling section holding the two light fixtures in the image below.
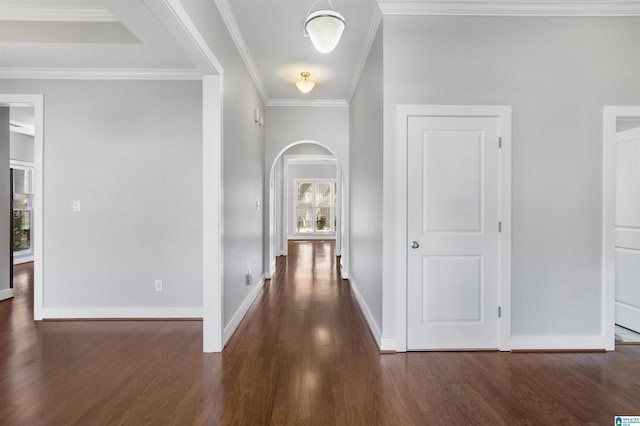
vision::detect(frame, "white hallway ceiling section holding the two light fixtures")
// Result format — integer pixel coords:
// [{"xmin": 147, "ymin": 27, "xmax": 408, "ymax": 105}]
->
[{"xmin": 225, "ymin": 0, "xmax": 380, "ymax": 102}]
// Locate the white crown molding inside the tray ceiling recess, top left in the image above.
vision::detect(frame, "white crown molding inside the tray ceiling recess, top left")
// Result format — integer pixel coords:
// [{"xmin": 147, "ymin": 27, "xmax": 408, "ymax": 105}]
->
[{"xmin": 0, "ymin": 3, "xmax": 118, "ymax": 22}]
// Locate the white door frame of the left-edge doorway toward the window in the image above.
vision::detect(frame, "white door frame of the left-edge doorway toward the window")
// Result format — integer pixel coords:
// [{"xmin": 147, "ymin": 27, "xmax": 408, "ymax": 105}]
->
[{"xmin": 0, "ymin": 94, "xmax": 44, "ymax": 320}]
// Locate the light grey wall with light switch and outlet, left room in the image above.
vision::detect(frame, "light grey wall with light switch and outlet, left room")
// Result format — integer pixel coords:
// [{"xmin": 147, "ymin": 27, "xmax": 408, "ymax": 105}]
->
[{"xmin": 0, "ymin": 80, "xmax": 202, "ymax": 317}]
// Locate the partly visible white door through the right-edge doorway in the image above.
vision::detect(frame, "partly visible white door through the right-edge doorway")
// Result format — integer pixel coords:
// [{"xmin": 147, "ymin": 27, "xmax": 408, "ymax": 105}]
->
[{"xmin": 615, "ymin": 129, "xmax": 640, "ymax": 332}]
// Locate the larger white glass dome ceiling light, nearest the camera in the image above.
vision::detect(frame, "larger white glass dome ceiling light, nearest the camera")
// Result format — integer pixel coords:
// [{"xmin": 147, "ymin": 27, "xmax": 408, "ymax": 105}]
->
[{"xmin": 304, "ymin": 0, "xmax": 346, "ymax": 53}]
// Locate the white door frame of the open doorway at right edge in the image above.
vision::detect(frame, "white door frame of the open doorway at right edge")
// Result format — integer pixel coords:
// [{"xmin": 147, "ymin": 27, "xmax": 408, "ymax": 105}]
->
[{"xmin": 602, "ymin": 106, "xmax": 640, "ymax": 351}]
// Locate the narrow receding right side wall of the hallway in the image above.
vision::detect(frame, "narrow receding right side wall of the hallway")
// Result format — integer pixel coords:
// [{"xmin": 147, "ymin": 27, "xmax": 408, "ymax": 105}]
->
[{"xmin": 349, "ymin": 27, "xmax": 382, "ymax": 343}]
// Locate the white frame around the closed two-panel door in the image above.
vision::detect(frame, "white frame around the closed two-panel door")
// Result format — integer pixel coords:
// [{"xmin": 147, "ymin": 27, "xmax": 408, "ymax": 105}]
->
[{"xmin": 394, "ymin": 105, "xmax": 511, "ymax": 352}]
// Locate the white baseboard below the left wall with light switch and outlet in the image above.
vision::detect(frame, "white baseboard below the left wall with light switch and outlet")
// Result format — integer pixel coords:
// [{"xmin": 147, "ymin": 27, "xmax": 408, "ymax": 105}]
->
[{"xmin": 41, "ymin": 307, "xmax": 202, "ymax": 319}]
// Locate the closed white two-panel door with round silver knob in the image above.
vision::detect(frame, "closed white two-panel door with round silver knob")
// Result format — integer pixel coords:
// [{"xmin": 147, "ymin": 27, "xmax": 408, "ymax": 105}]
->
[{"xmin": 407, "ymin": 117, "xmax": 500, "ymax": 350}]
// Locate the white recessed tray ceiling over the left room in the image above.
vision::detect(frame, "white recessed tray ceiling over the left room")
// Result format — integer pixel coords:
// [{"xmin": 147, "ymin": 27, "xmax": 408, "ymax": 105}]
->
[{"xmin": 0, "ymin": 0, "xmax": 193, "ymax": 69}]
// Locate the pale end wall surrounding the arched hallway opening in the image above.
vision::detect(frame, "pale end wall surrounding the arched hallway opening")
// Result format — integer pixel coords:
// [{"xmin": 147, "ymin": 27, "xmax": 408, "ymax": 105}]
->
[{"xmin": 264, "ymin": 106, "xmax": 349, "ymax": 272}]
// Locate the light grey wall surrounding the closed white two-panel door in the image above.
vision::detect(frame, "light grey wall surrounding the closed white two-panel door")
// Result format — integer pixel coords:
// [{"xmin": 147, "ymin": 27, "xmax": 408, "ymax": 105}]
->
[{"xmin": 384, "ymin": 16, "xmax": 640, "ymax": 341}]
